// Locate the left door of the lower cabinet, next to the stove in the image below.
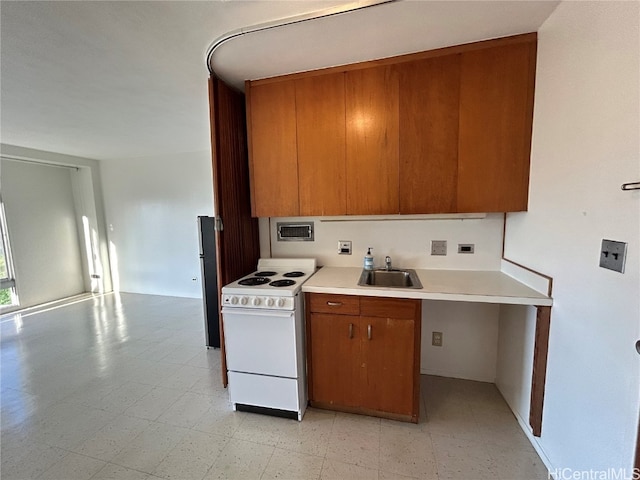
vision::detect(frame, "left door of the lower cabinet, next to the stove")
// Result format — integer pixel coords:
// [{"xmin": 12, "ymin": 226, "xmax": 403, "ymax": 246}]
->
[{"xmin": 310, "ymin": 313, "xmax": 362, "ymax": 407}]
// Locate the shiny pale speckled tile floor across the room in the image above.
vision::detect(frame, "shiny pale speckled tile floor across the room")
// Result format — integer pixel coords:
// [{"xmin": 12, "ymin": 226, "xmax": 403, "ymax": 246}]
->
[{"xmin": 0, "ymin": 294, "xmax": 547, "ymax": 480}]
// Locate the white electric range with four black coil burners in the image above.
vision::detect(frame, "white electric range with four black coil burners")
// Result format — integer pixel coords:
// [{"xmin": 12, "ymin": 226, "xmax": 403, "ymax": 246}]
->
[{"xmin": 222, "ymin": 258, "xmax": 316, "ymax": 420}]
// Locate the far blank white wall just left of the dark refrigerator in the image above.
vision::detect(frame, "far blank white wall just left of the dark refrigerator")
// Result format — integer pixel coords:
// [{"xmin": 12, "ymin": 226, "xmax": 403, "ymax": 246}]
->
[{"xmin": 101, "ymin": 151, "xmax": 213, "ymax": 298}]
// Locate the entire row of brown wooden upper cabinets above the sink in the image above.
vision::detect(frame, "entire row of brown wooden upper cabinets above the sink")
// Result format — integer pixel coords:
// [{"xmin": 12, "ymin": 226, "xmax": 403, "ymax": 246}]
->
[{"xmin": 246, "ymin": 33, "xmax": 537, "ymax": 217}]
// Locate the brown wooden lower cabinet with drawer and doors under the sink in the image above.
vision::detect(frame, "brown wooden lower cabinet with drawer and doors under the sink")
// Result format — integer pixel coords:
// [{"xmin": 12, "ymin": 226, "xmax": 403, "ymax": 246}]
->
[{"xmin": 306, "ymin": 294, "xmax": 421, "ymax": 423}]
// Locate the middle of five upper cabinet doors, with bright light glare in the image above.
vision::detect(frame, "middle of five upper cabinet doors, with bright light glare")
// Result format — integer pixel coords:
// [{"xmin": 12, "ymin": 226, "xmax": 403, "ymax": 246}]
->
[{"xmin": 346, "ymin": 66, "xmax": 400, "ymax": 215}]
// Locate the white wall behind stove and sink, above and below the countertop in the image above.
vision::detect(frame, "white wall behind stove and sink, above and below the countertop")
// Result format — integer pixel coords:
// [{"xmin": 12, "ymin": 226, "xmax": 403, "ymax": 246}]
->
[{"xmin": 260, "ymin": 214, "xmax": 503, "ymax": 382}]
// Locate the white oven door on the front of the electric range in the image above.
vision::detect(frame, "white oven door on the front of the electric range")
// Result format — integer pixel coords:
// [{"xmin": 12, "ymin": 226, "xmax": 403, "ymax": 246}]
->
[{"xmin": 222, "ymin": 307, "xmax": 299, "ymax": 378}]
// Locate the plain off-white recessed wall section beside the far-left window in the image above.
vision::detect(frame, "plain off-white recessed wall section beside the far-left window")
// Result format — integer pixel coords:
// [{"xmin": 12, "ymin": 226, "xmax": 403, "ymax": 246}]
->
[{"xmin": 1, "ymin": 158, "xmax": 85, "ymax": 307}]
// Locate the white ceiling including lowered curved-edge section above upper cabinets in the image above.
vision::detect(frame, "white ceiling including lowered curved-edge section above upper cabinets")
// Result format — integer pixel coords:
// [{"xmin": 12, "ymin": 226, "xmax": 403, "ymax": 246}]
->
[{"xmin": 0, "ymin": 0, "xmax": 558, "ymax": 160}]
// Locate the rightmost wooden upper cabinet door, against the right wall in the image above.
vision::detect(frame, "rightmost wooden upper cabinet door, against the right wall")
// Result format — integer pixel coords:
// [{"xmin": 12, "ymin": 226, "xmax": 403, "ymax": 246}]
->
[{"xmin": 458, "ymin": 39, "xmax": 536, "ymax": 212}]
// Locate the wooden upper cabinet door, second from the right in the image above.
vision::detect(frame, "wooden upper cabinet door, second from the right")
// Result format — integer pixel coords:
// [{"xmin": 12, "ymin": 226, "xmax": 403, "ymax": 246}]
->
[{"xmin": 398, "ymin": 55, "xmax": 460, "ymax": 214}]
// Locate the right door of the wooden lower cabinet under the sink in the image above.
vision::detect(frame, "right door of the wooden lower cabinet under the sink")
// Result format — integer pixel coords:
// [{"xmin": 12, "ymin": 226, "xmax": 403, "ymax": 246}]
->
[{"xmin": 360, "ymin": 317, "xmax": 418, "ymax": 418}]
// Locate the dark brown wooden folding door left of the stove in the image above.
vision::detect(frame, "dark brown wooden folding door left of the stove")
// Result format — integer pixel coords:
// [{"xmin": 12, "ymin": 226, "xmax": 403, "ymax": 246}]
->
[{"xmin": 209, "ymin": 77, "xmax": 260, "ymax": 386}]
